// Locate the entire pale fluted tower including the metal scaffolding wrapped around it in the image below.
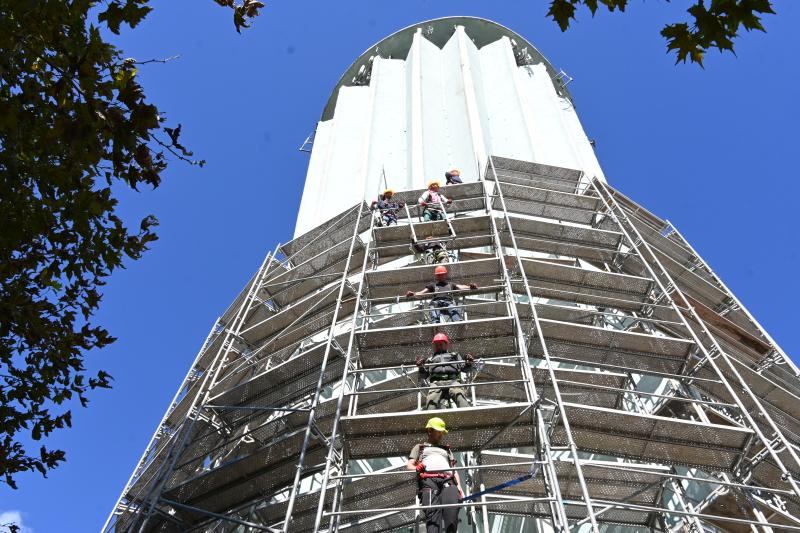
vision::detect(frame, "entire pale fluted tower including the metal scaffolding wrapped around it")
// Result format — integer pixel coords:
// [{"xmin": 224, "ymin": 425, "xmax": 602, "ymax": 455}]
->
[{"xmin": 103, "ymin": 17, "xmax": 800, "ymax": 533}]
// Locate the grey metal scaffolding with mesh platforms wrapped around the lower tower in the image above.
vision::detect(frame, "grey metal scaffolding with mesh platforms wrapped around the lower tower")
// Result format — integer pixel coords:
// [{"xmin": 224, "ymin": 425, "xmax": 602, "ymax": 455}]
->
[{"xmin": 103, "ymin": 157, "xmax": 800, "ymax": 533}]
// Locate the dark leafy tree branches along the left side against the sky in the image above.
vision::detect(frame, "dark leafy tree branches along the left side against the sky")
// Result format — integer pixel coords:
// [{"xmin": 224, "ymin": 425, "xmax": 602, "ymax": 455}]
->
[{"xmin": 0, "ymin": 0, "xmax": 263, "ymax": 488}]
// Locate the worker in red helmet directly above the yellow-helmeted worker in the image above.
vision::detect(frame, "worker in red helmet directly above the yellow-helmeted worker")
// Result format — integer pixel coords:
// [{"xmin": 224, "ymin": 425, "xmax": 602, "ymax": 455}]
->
[{"xmin": 416, "ymin": 333, "xmax": 475, "ymax": 410}]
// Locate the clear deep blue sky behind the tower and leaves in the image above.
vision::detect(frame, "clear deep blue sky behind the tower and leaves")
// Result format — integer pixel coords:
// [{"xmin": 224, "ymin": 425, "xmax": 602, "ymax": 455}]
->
[{"xmin": 0, "ymin": 0, "xmax": 800, "ymax": 533}]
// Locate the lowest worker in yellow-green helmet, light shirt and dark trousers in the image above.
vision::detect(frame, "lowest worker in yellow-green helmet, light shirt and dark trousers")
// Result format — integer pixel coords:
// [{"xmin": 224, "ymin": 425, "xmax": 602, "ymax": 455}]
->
[{"xmin": 406, "ymin": 417, "xmax": 464, "ymax": 533}]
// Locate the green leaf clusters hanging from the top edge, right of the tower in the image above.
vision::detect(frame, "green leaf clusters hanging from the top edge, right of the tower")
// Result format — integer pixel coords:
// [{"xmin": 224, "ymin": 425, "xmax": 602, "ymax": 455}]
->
[{"xmin": 547, "ymin": 0, "xmax": 775, "ymax": 66}]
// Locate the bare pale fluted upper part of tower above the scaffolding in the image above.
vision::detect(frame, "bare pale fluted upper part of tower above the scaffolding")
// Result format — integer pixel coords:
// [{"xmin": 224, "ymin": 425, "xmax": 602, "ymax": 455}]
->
[{"xmin": 295, "ymin": 17, "xmax": 602, "ymax": 236}]
